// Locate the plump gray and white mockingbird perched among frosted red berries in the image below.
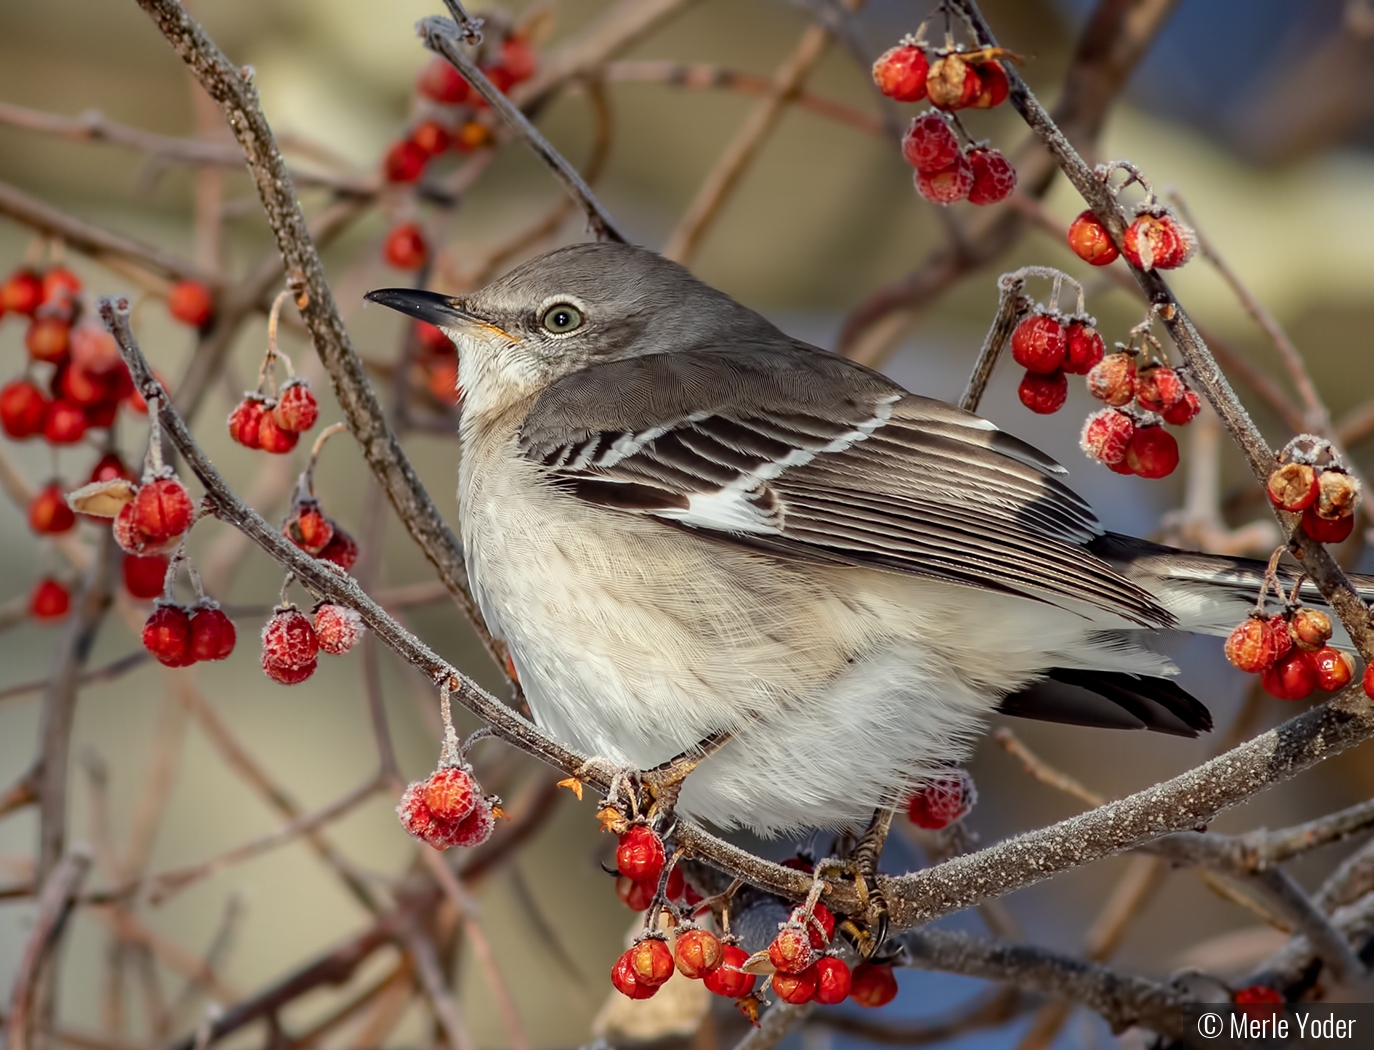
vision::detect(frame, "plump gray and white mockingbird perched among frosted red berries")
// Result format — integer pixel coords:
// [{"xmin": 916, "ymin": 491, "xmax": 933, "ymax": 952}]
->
[{"xmin": 367, "ymin": 243, "xmax": 1374, "ymax": 834}]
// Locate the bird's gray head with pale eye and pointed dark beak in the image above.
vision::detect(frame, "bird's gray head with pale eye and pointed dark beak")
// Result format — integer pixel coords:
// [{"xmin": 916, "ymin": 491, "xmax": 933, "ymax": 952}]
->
[{"xmin": 367, "ymin": 243, "xmax": 786, "ymax": 412}]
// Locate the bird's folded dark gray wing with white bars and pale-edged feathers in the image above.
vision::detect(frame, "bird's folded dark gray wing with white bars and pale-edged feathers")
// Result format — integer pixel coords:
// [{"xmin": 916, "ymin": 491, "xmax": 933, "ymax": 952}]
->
[{"xmin": 519, "ymin": 344, "xmax": 1172, "ymax": 627}]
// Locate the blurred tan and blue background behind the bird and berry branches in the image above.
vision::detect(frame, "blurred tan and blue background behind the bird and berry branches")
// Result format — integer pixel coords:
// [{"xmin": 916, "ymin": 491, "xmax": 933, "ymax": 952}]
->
[{"xmin": 0, "ymin": 0, "xmax": 1374, "ymax": 1050}]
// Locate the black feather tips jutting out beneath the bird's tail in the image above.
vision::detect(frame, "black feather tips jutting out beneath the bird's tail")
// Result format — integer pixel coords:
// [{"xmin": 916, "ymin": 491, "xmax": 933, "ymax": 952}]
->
[{"xmin": 998, "ymin": 668, "xmax": 1212, "ymax": 737}]
